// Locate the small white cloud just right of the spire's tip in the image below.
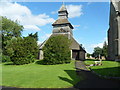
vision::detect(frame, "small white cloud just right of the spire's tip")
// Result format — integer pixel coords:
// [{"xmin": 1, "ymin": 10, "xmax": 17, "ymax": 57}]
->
[{"xmin": 66, "ymin": 4, "xmax": 83, "ymax": 18}]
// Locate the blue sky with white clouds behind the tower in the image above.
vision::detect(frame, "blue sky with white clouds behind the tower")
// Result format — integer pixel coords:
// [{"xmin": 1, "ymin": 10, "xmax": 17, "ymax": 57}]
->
[{"xmin": 0, "ymin": 2, "xmax": 110, "ymax": 53}]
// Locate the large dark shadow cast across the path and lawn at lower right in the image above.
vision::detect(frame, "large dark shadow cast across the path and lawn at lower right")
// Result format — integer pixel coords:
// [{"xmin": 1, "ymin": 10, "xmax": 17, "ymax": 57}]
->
[{"xmin": 58, "ymin": 68, "xmax": 120, "ymax": 89}]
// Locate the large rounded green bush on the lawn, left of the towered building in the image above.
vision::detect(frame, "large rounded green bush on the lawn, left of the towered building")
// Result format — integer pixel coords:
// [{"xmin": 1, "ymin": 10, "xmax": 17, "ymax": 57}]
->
[{"xmin": 7, "ymin": 37, "xmax": 38, "ymax": 65}]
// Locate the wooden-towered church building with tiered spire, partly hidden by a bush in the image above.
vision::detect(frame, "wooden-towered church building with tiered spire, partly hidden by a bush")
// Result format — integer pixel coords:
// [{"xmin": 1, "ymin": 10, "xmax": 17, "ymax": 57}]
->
[{"xmin": 39, "ymin": 4, "xmax": 86, "ymax": 60}]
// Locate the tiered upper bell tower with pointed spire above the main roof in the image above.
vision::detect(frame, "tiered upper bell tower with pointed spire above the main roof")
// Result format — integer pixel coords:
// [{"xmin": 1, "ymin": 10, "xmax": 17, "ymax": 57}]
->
[{"xmin": 52, "ymin": 4, "xmax": 73, "ymax": 37}]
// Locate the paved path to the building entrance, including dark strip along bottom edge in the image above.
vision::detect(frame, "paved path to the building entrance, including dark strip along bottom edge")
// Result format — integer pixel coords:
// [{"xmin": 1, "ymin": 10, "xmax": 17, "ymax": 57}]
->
[{"xmin": 0, "ymin": 61, "xmax": 120, "ymax": 90}]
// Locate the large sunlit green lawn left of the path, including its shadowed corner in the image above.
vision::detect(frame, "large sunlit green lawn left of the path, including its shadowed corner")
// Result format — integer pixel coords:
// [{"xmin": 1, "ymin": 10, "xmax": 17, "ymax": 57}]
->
[{"xmin": 0, "ymin": 61, "xmax": 81, "ymax": 88}]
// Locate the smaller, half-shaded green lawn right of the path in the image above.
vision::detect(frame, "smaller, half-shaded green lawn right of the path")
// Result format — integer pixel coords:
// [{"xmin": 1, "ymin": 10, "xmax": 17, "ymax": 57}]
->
[{"xmin": 85, "ymin": 59, "xmax": 120, "ymax": 77}]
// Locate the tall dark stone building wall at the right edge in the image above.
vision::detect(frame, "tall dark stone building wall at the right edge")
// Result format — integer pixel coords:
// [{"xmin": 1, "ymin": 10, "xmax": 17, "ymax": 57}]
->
[{"xmin": 108, "ymin": 0, "xmax": 120, "ymax": 61}]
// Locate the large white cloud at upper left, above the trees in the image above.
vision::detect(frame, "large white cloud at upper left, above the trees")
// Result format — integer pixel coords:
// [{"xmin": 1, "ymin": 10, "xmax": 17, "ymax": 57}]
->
[{"xmin": 0, "ymin": 2, "xmax": 54, "ymax": 30}]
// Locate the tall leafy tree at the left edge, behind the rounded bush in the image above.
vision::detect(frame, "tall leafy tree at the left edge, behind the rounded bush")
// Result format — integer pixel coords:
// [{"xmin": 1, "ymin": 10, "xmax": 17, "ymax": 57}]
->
[{"xmin": 0, "ymin": 16, "xmax": 23, "ymax": 55}]
